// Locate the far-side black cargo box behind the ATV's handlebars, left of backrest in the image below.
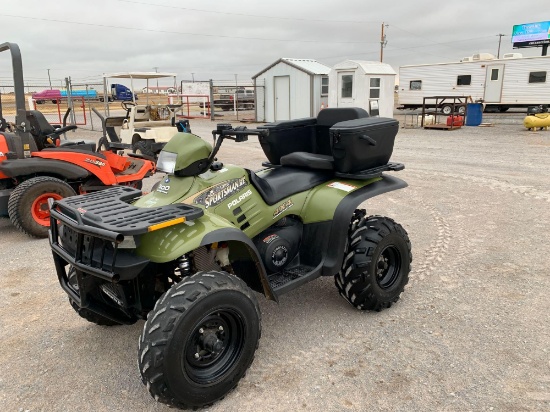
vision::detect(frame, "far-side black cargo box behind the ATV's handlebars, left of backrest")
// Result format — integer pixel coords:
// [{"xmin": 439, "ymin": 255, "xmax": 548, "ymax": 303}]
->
[{"xmin": 258, "ymin": 117, "xmax": 317, "ymax": 165}]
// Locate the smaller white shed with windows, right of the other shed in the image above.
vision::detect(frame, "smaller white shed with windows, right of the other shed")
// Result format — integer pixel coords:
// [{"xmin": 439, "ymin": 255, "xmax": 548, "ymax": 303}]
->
[{"xmin": 328, "ymin": 60, "xmax": 397, "ymax": 117}]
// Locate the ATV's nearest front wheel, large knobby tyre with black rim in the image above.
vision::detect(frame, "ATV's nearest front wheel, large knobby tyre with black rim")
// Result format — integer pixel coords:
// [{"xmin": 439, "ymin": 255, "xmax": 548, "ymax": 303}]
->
[{"xmin": 138, "ymin": 272, "xmax": 261, "ymax": 409}]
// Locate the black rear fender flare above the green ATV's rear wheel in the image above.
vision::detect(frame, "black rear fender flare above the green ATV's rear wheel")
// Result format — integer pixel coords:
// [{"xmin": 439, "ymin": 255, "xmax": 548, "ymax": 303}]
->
[{"xmin": 322, "ymin": 175, "xmax": 408, "ymax": 276}]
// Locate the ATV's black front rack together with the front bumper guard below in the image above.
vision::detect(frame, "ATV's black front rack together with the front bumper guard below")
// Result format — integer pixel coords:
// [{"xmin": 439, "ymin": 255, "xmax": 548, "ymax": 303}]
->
[{"xmin": 50, "ymin": 186, "xmax": 203, "ymax": 286}]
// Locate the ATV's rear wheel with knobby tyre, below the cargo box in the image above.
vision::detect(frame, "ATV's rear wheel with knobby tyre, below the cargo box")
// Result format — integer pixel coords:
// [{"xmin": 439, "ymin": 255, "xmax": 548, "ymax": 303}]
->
[{"xmin": 335, "ymin": 211, "xmax": 412, "ymax": 311}]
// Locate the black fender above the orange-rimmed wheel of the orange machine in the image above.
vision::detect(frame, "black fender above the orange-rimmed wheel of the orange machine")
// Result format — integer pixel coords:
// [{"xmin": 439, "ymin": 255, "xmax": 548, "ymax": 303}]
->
[{"xmin": 0, "ymin": 158, "xmax": 90, "ymax": 180}]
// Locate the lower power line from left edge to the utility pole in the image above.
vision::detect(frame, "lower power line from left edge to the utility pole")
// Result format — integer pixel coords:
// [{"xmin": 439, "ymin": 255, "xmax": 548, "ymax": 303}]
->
[{"xmin": 2, "ymin": 14, "xmax": 382, "ymax": 44}]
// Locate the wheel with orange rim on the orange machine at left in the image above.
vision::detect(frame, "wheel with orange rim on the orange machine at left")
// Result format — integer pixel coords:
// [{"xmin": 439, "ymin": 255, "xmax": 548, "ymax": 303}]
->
[{"xmin": 8, "ymin": 176, "xmax": 76, "ymax": 237}]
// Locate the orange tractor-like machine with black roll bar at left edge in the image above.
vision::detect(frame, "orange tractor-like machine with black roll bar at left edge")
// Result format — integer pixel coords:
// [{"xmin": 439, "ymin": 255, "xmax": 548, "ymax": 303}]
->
[{"xmin": 0, "ymin": 43, "xmax": 155, "ymax": 237}]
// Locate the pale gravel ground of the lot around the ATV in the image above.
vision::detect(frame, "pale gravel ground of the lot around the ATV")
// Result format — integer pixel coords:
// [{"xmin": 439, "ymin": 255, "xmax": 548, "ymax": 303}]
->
[{"xmin": 0, "ymin": 117, "xmax": 550, "ymax": 411}]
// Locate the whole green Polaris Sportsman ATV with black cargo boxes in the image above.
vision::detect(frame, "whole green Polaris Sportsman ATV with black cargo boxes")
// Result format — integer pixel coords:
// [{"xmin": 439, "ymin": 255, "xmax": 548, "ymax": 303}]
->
[{"xmin": 50, "ymin": 108, "xmax": 412, "ymax": 408}]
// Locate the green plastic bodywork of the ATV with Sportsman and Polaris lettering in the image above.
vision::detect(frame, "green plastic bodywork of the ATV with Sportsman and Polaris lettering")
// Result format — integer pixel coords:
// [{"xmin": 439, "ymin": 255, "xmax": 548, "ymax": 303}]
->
[{"xmin": 135, "ymin": 166, "xmax": 380, "ymax": 263}]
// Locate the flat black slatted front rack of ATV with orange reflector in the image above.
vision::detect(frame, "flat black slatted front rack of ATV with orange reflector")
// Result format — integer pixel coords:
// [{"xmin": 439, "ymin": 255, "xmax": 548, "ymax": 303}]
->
[{"xmin": 51, "ymin": 186, "xmax": 204, "ymax": 237}]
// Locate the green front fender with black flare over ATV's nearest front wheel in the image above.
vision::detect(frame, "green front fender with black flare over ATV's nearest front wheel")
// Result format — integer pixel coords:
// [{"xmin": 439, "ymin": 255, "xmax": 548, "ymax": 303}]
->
[{"xmin": 137, "ymin": 213, "xmax": 277, "ymax": 300}]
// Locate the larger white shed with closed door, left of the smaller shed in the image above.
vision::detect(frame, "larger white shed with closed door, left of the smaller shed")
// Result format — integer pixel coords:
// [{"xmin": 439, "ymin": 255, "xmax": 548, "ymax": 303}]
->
[{"xmin": 252, "ymin": 58, "xmax": 330, "ymax": 122}]
